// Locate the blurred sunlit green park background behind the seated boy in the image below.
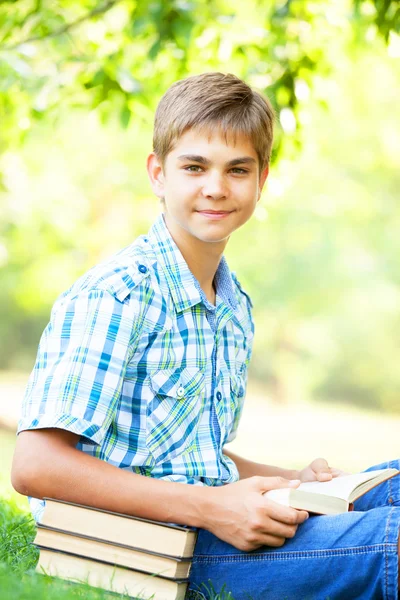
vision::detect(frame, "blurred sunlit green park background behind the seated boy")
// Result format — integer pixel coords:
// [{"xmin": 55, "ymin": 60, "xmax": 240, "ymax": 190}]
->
[{"xmin": 0, "ymin": 0, "xmax": 400, "ymax": 506}]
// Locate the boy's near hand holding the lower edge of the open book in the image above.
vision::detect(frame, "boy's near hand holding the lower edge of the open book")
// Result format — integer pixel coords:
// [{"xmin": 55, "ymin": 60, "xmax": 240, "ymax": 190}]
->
[{"xmin": 203, "ymin": 476, "xmax": 308, "ymax": 551}]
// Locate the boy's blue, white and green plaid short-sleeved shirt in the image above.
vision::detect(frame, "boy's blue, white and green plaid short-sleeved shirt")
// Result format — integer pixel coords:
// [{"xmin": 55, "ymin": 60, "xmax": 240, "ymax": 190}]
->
[{"xmin": 18, "ymin": 215, "xmax": 254, "ymax": 519}]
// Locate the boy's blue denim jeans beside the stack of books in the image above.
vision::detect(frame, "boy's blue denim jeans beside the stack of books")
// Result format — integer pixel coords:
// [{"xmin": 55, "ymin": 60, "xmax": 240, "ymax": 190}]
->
[{"xmin": 188, "ymin": 460, "xmax": 400, "ymax": 600}]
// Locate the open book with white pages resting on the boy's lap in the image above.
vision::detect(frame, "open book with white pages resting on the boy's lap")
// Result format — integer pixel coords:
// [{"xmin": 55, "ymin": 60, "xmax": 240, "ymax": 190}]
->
[{"xmin": 264, "ymin": 469, "xmax": 400, "ymax": 515}]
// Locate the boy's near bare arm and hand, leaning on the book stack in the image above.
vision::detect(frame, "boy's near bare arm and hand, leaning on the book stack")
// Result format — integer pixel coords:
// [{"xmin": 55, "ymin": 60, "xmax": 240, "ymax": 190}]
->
[{"xmin": 12, "ymin": 429, "xmax": 308, "ymax": 550}]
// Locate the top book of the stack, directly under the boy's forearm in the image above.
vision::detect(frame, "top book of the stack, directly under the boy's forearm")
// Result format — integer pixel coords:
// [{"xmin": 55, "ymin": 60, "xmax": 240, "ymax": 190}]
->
[{"xmin": 40, "ymin": 498, "xmax": 197, "ymax": 558}]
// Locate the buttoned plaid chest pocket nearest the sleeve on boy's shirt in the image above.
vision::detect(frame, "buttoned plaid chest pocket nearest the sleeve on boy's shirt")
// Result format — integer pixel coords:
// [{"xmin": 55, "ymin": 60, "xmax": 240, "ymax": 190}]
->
[{"xmin": 146, "ymin": 368, "xmax": 205, "ymax": 463}]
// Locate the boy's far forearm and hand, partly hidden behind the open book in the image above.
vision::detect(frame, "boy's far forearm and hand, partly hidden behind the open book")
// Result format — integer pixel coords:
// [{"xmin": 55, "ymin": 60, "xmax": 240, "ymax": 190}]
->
[{"xmin": 224, "ymin": 448, "xmax": 343, "ymax": 482}]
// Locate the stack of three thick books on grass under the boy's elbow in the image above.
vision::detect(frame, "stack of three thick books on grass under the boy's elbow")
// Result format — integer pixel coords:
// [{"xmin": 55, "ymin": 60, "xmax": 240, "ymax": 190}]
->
[{"xmin": 34, "ymin": 498, "xmax": 197, "ymax": 600}]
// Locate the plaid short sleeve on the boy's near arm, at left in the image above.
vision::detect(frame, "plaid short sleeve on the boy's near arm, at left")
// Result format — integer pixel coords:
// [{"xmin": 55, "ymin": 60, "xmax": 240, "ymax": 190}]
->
[{"xmin": 18, "ymin": 289, "xmax": 137, "ymax": 444}]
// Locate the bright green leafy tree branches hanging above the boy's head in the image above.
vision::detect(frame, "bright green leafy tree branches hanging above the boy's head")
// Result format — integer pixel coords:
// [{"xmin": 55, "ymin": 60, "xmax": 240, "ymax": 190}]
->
[{"xmin": 0, "ymin": 0, "xmax": 400, "ymax": 157}]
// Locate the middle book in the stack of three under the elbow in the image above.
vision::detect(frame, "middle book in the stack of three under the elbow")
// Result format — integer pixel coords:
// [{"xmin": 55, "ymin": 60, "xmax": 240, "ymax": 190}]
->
[{"xmin": 34, "ymin": 525, "xmax": 191, "ymax": 579}]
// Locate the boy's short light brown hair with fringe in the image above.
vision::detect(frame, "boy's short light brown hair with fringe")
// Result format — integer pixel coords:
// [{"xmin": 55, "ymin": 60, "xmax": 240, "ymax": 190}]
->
[{"xmin": 153, "ymin": 72, "xmax": 274, "ymax": 169}]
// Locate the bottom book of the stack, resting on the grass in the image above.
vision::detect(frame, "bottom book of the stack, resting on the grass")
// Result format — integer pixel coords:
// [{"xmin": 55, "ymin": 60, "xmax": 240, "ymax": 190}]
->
[{"xmin": 36, "ymin": 548, "xmax": 188, "ymax": 600}]
